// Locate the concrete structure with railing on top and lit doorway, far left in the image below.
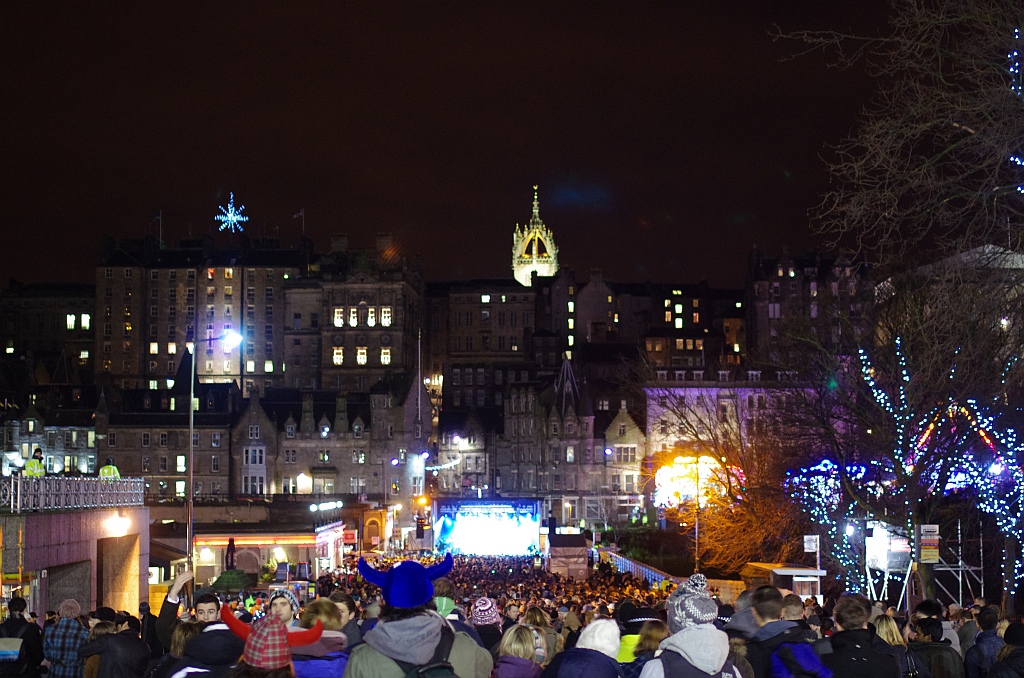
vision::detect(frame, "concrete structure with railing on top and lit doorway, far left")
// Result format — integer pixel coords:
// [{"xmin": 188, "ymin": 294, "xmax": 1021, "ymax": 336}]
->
[{"xmin": 0, "ymin": 476, "xmax": 150, "ymax": 616}]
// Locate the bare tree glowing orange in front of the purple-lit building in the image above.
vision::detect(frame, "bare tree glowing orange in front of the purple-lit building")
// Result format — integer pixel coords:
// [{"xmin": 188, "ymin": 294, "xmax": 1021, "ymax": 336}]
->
[{"xmin": 634, "ymin": 365, "xmax": 807, "ymax": 573}]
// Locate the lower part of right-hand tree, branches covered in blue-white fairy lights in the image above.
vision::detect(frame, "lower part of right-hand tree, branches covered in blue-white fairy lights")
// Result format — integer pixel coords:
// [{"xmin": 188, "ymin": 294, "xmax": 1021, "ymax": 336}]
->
[{"xmin": 787, "ymin": 338, "xmax": 1024, "ymax": 606}]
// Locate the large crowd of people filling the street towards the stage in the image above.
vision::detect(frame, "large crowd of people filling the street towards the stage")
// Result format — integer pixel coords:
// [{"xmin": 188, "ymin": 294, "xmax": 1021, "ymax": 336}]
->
[{"xmin": 0, "ymin": 556, "xmax": 1024, "ymax": 678}]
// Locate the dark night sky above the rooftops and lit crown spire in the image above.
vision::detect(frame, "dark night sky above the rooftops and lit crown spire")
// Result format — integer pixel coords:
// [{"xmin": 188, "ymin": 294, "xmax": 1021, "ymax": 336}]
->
[{"xmin": 0, "ymin": 0, "xmax": 881, "ymax": 285}]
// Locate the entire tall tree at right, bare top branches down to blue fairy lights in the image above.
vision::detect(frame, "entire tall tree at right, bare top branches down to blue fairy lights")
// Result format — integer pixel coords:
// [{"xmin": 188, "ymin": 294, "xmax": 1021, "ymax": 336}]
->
[{"xmin": 769, "ymin": 0, "xmax": 1024, "ymax": 606}]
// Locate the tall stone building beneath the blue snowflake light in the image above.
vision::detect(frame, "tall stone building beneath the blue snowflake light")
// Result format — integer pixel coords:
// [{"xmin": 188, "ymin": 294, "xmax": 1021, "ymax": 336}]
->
[{"xmin": 92, "ymin": 236, "xmax": 311, "ymax": 394}]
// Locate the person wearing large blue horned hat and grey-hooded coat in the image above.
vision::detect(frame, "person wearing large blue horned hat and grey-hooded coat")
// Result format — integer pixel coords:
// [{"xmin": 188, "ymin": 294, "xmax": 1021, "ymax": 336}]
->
[{"xmin": 345, "ymin": 556, "xmax": 494, "ymax": 678}]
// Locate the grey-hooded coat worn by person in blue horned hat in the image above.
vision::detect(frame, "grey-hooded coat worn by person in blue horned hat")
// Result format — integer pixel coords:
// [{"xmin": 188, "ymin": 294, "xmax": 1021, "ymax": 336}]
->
[{"xmin": 345, "ymin": 613, "xmax": 494, "ymax": 678}]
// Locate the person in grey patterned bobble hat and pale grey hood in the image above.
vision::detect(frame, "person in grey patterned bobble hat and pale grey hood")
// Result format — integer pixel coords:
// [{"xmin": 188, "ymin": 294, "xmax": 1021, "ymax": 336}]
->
[{"xmin": 640, "ymin": 574, "xmax": 740, "ymax": 678}]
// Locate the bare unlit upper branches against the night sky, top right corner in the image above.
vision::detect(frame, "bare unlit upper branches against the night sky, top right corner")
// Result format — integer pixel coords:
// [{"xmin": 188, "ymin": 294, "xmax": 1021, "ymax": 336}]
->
[{"xmin": 787, "ymin": 0, "xmax": 1024, "ymax": 276}]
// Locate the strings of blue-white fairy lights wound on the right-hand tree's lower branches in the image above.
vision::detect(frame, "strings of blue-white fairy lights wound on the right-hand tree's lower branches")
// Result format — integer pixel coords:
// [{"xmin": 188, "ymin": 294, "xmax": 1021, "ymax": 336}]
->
[{"xmin": 786, "ymin": 338, "xmax": 1024, "ymax": 593}]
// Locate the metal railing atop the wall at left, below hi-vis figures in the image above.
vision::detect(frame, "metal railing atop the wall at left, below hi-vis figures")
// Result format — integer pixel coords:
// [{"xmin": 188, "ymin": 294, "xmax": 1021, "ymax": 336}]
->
[{"xmin": 0, "ymin": 475, "xmax": 145, "ymax": 513}]
